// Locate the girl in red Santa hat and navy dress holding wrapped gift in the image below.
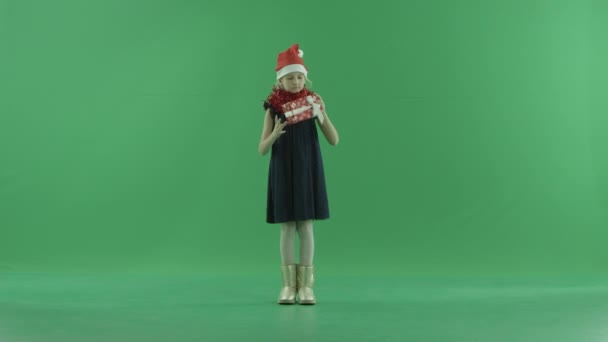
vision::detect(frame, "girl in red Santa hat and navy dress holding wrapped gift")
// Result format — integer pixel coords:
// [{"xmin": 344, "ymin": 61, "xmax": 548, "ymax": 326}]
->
[{"xmin": 259, "ymin": 44, "xmax": 338, "ymax": 304}]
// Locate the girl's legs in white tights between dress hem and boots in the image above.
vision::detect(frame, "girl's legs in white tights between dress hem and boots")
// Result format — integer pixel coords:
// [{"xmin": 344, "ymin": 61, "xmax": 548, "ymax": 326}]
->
[{"xmin": 281, "ymin": 220, "xmax": 315, "ymax": 266}]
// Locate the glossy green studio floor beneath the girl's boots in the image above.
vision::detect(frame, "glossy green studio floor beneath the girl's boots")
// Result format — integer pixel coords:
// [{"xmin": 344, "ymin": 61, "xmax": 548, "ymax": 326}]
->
[{"xmin": 0, "ymin": 273, "xmax": 608, "ymax": 342}]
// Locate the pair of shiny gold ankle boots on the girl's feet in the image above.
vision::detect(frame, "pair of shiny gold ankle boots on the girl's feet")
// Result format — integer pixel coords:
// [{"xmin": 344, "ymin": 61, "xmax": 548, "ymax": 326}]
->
[{"xmin": 278, "ymin": 265, "xmax": 317, "ymax": 305}]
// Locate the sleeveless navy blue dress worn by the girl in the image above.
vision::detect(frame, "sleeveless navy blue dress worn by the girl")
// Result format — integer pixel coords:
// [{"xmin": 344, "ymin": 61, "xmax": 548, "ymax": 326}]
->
[{"xmin": 264, "ymin": 102, "xmax": 329, "ymax": 223}]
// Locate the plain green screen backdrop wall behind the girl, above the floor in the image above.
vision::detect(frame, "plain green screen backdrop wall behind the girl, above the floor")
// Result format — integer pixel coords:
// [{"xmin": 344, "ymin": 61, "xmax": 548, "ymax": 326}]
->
[{"xmin": 0, "ymin": 0, "xmax": 608, "ymax": 275}]
